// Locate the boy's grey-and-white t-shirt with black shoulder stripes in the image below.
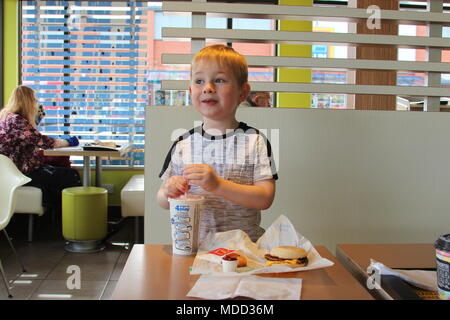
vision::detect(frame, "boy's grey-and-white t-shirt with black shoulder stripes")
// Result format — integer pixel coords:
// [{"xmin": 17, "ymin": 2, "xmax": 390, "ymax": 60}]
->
[{"xmin": 159, "ymin": 122, "xmax": 278, "ymax": 241}]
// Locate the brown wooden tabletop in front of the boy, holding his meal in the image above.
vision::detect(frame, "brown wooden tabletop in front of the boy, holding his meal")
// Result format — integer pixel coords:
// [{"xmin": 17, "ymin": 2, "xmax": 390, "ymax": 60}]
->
[{"xmin": 112, "ymin": 245, "xmax": 373, "ymax": 300}]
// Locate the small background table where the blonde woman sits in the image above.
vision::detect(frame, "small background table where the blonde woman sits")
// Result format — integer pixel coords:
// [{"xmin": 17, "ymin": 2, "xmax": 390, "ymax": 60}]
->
[{"xmin": 44, "ymin": 144, "xmax": 132, "ymax": 187}]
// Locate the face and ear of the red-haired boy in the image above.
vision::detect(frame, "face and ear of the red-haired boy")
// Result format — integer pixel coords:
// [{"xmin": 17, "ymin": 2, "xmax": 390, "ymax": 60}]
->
[{"xmin": 189, "ymin": 60, "xmax": 250, "ymax": 121}]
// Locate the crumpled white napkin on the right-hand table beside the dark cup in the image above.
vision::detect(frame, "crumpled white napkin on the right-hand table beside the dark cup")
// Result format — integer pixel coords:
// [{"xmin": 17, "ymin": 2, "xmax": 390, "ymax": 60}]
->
[{"xmin": 369, "ymin": 259, "xmax": 437, "ymax": 291}]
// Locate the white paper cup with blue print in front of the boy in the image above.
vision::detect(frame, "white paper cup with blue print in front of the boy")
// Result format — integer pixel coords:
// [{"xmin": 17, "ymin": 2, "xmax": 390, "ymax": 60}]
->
[{"xmin": 169, "ymin": 195, "xmax": 204, "ymax": 256}]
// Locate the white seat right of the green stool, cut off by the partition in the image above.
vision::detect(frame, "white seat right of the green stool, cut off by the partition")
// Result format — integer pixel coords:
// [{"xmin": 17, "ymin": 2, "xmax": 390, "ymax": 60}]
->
[{"xmin": 120, "ymin": 174, "xmax": 145, "ymax": 242}]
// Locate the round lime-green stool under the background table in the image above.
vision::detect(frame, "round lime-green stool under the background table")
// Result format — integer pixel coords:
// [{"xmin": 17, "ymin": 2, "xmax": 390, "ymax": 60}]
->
[{"xmin": 62, "ymin": 187, "xmax": 108, "ymax": 253}]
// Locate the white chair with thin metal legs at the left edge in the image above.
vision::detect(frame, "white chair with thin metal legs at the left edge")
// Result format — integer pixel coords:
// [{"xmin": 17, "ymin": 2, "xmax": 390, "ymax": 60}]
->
[{"xmin": 0, "ymin": 154, "xmax": 31, "ymax": 298}]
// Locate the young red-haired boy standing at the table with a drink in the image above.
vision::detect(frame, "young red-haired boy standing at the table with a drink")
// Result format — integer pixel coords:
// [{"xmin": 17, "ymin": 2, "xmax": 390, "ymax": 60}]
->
[{"xmin": 157, "ymin": 45, "xmax": 278, "ymax": 241}]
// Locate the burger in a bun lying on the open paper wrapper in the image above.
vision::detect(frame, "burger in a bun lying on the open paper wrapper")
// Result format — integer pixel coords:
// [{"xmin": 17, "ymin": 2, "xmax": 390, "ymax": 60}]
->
[{"xmin": 264, "ymin": 246, "xmax": 308, "ymax": 268}]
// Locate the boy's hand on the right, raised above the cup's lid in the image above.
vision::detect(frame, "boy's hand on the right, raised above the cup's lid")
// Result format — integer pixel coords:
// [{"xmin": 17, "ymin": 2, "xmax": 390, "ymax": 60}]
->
[{"xmin": 183, "ymin": 164, "xmax": 221, "ymax": 192}]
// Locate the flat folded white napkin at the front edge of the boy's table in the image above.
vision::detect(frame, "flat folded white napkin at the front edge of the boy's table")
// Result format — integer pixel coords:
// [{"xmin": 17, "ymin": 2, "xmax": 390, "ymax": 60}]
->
[{"xmin": 187, "ymin": 275, "xmax": 302, "ymax": 300}]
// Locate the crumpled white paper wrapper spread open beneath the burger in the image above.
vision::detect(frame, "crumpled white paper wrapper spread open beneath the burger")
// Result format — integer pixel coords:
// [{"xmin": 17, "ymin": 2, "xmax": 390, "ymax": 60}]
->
[{"xmin": 190, "ymin": 215, "xmax": 334, "ymax": 277}]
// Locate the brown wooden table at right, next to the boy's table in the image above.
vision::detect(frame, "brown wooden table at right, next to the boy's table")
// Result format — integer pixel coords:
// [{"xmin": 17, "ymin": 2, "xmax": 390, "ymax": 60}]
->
[{"xmin": 336, "ymin": 243, "xmax": 436, "ymax": 300}]
